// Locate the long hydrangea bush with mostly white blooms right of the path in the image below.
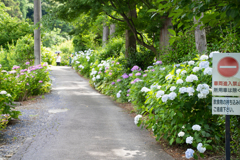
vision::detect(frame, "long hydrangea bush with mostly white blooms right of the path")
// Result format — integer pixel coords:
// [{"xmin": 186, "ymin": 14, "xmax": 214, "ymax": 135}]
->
[{"xmin": 72, "ymin": 50, "xmax": 240, "ymax": 159}]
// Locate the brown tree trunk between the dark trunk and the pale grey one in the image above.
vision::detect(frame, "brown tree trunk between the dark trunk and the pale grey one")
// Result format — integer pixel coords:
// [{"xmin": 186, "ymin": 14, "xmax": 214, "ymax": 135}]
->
[{"xmin": 158, "ymin": 17, "xmax": 173, "ymax": 58}]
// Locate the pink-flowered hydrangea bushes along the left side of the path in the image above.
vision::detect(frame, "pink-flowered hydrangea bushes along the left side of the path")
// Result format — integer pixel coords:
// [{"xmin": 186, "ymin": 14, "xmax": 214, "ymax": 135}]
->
[{"xmin": 0, "ymin": 62, "xmax": 51, "ymax": 128}]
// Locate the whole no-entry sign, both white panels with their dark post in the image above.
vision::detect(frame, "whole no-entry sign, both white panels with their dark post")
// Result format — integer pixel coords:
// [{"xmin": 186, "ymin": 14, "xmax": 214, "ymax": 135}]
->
[{"xmin": 212, "ymin": 53, "xmax": 240, "ymax": 160}]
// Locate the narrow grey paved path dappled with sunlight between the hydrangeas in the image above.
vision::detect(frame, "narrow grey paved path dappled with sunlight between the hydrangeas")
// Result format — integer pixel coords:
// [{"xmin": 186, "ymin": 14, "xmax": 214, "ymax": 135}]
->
[{"xmin": 11, "ymin": 67, "xmax": 173, "ymax": 160}]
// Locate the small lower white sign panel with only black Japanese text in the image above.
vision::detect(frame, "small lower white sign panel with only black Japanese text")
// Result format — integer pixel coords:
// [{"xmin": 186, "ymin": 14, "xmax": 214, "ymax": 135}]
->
[{"xmin": 212, "ymin": 97, "xmax": 240, "ymax": 115}]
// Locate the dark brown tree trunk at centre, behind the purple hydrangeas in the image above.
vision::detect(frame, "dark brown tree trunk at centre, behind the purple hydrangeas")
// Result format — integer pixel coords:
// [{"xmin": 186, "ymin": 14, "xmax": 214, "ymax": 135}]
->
[{"xmin": 125, "ymin": 6, "xmax": 137, "ymax": 58}]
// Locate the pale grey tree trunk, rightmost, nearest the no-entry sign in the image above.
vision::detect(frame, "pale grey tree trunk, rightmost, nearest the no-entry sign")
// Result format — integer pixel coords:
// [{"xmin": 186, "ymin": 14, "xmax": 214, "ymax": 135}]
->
[{"xmin": 193, "ymin": 13, "xmax": 207, "ymax": 53}]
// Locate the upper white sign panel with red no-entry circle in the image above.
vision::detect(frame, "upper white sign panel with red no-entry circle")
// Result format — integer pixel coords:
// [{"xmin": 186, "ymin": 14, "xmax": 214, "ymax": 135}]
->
[{"xmin": 212, "ymin": 53, "xmax": 240, "ymax": 96}]
